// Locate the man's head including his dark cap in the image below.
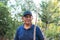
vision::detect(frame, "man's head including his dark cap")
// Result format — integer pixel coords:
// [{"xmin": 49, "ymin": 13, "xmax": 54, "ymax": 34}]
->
[{"xmin": 22, "ymin": 11, "xmax": 32, "ymax": 24}]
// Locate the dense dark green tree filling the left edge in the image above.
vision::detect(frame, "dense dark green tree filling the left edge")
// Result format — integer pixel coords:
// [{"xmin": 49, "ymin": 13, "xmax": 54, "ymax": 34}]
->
[{"xmin": 0, "ymin": 3, "xmax": 21, "ymax": 40}]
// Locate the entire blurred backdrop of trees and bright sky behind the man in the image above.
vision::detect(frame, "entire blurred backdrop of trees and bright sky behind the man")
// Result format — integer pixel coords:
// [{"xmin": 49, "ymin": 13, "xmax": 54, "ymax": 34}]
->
[{"xmin": 0, "ymin": 0, "xmax": 60, "ymax": 40}]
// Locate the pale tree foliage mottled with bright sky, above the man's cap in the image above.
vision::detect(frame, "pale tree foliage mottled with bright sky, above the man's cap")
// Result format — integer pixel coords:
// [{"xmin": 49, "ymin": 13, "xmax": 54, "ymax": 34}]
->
[{"xmin": 7, "ymin": 0, "xmax": 36, "ymax": 20}]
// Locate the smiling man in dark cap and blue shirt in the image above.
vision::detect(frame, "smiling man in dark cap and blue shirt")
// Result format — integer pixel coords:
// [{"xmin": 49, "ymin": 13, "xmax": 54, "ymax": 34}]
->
[{"xmin": 14, "ymin": 11, "xmax": 44, "ymax": 40}]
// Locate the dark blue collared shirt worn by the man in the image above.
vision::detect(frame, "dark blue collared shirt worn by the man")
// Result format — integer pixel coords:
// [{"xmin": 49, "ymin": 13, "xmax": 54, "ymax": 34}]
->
[{"xmin": 14, "ymin": 24, "xmax": 44, "ymax": 40}]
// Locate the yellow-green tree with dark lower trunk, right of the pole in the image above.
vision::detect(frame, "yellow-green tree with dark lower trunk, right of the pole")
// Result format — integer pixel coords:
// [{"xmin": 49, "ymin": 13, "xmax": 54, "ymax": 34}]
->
[{"xmin": 39, "ymin": 1, "xmax": 59, "ymax": 28}]
